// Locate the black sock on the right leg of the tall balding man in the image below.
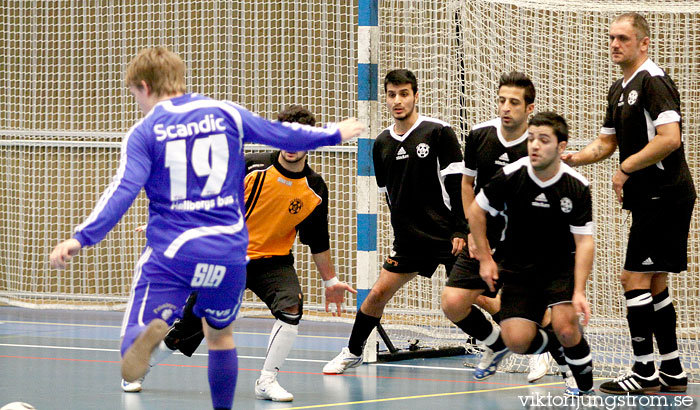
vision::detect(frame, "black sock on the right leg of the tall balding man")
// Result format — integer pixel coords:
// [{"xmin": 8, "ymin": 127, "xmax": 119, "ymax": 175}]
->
[{"xmin": 652, "ymin": 288, "xmax": 683, "ymax": 376}]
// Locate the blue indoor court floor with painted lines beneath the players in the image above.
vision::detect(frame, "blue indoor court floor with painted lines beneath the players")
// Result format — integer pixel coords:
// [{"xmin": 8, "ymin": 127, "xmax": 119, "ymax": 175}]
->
[{"xmin": 0, "ymin": 306, "xmax": 700, "ymax": 410}]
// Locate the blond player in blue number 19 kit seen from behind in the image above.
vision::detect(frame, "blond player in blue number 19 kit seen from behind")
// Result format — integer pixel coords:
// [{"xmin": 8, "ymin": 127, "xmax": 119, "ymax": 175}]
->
[{"xmin": 50, "ymin": 47, "xmax": 364, "ymax": 409}]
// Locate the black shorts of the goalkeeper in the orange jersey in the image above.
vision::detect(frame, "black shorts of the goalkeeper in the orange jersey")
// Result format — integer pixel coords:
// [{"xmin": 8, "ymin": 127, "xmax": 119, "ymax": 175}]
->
[{"xmin": 246, "ymin": 255, "xmax": 304, "ymax": 314}]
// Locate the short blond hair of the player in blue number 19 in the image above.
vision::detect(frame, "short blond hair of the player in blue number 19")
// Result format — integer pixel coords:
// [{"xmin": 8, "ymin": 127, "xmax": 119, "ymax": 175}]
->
[{"xmin": 124, "ymin": 47, "xmax": 185, "ymax": 96}]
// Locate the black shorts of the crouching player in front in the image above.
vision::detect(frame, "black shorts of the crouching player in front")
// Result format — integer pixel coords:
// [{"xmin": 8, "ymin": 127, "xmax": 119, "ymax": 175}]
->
[{"xmin": 499, "ymin": 265, "xmax": 574, "ymax": 323}]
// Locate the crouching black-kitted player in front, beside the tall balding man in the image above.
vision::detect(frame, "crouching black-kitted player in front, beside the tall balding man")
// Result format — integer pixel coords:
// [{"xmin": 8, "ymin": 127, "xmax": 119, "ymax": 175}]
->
[{"xmin": 467, "ymin": 112, "xmax": 594, "ymax": 395}]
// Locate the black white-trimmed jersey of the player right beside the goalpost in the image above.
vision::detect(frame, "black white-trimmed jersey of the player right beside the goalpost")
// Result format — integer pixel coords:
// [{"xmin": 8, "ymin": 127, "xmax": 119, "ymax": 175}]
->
[{"xmin": 372, "ymin": 116, "xmax": 467, "ymax": 252}]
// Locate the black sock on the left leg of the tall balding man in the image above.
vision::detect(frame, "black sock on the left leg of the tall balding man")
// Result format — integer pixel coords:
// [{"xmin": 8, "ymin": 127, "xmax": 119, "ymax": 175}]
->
[{"xmin": 625, "ymin": 289, "xmax": 654, "ymax": 377}]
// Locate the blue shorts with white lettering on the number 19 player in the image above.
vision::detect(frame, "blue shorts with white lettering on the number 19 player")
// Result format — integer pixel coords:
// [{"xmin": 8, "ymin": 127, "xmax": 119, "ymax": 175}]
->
[{"xmin": 121, "ymin": 247, "xmax": 246, "ymax": 354}]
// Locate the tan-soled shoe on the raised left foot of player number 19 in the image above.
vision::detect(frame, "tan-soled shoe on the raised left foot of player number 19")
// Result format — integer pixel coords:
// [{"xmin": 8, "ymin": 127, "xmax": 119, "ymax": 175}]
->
[{"xmin": 121, "ymin": 319, "xmax": 168, "ymax": 382}]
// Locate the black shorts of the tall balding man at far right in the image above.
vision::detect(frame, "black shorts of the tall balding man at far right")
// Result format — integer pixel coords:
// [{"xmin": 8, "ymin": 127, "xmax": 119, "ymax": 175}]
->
[{"xmin": 624, "ymin": 199, "xmax": 695, "ymax": 273}]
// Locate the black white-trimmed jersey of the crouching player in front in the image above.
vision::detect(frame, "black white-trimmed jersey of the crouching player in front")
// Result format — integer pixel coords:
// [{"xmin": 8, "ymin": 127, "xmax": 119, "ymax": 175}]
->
[{"xmin": 475, "ymin": 157, "xmax": 594, "ymax": 272}]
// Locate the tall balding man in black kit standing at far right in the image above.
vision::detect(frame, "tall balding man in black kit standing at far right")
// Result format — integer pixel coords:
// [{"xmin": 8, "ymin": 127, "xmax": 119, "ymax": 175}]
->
[{"xmin": 563, "ymin": 13, "xmax": 696, "ymax": 394}]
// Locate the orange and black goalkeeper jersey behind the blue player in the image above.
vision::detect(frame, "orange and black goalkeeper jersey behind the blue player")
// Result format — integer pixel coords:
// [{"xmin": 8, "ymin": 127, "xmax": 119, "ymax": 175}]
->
[{"xmin": 245, "ymin": 151, "xmax": 330, "ymax": 259}]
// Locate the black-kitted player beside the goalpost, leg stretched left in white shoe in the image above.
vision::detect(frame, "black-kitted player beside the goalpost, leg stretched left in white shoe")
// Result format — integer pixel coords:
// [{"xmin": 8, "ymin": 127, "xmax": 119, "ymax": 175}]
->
[{"xmin": 323, "ymin": 70, "xmax": 467, "ymax": 374}]
